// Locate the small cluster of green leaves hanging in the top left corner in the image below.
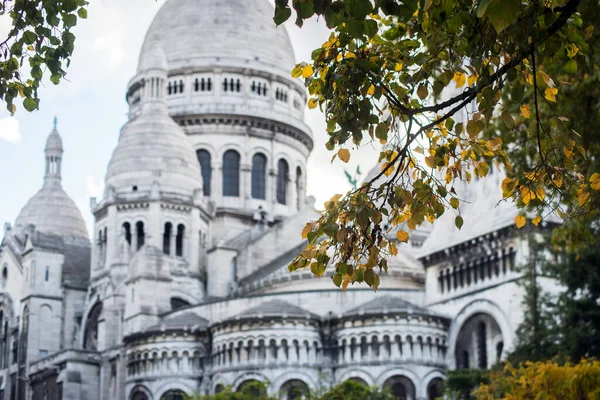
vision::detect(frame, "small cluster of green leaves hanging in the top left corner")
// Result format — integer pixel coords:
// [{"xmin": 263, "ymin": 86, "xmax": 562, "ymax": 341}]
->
[{"xmin": 0, "ymin": 0, "xmax": 88, "ymax": 114}]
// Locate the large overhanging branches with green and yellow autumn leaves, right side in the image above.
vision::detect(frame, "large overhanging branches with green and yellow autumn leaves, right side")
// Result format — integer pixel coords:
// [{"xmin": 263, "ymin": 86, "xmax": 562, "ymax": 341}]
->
[{"xmin": 274, "ymin": 0, "xmax": 600, "ymax": 289}]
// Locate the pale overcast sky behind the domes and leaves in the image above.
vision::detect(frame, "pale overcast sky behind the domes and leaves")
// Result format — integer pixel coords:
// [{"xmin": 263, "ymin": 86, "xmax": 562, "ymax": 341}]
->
[{"xmin": 0, "ymin": 0, "xmax": 376, "ymax": 236}]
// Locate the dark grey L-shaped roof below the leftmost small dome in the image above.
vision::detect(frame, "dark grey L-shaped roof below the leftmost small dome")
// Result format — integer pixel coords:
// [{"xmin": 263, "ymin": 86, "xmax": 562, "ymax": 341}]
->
[{"xmin": 31, "ymin": 231, "xmax": 91, "ymax": 288}]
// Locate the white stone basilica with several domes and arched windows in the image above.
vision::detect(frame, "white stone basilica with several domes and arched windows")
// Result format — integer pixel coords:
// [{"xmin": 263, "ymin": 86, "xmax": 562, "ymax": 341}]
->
[{"xmin": 0, "ymin": 0, "xmax": 548, "ymax": 400}]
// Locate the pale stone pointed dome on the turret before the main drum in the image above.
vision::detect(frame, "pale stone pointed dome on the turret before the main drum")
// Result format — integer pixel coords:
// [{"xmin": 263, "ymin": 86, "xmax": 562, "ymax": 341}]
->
[{"xmin": 106, "ymin": 112, "xmax": 202, "ymax": 198}]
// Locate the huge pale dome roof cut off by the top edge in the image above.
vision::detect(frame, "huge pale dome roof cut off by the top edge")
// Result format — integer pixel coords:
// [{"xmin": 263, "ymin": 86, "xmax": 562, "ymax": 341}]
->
[{"xmin": 140, "ymin": 0, "xmax": 295, "ymax": 77}]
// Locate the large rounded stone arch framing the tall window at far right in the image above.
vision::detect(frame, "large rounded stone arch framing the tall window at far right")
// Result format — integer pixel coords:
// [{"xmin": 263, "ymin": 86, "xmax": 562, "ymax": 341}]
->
[{"xmin": 448, "ymin": 299, "xmax": 514, "ymax": 369}]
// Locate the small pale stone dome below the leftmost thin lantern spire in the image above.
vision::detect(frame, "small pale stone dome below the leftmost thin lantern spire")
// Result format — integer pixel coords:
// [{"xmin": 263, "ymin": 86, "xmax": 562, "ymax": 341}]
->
[{"xmin": 15, "ymin": 185, "xmax": 88, "ymax": 238}]
